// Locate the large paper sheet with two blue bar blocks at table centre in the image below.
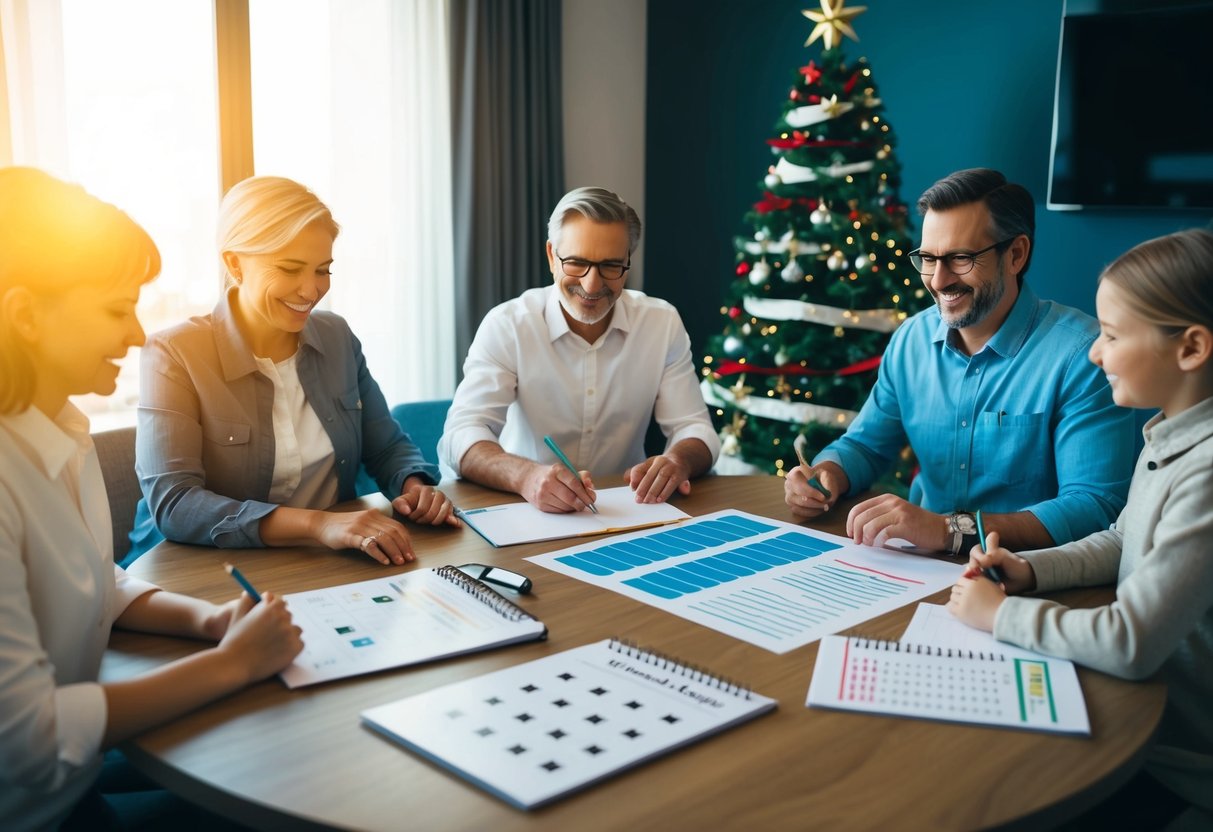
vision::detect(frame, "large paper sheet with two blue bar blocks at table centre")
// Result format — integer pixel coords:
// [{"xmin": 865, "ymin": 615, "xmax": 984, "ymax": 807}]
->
[{"xmin": 528, "ymin": 509, "xmax": 962, "ymax": 653}]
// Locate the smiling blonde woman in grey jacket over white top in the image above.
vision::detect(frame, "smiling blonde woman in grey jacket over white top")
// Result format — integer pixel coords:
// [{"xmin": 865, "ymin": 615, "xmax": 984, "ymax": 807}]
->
[{"xmin": 132, "ymin": 177, "xmax": 460, "ymax": 565}]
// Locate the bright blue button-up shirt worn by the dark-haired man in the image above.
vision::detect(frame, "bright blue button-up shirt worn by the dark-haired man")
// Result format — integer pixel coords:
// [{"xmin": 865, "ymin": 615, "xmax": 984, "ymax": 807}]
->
[{"xmin": 814, "ymin": 284, "xmax": 1134, "ymax": 543}]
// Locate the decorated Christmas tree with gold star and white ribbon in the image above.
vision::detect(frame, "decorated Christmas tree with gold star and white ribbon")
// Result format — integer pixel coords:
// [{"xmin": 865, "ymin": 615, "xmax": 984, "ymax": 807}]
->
[{"xmin": 701, "ymin": 0, "xmax": 930, "ymax": 488}]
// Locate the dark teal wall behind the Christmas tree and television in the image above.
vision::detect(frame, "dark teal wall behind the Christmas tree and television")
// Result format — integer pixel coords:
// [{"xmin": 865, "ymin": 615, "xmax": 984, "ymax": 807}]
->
[{"xmin": 655, "ymin": 0, "xmax": 1211, "ymax": 354}]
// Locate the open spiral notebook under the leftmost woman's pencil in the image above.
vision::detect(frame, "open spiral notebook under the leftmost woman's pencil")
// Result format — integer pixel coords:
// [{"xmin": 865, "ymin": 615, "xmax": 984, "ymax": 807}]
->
[{"xmin": 279, "ymin": 566, "xmax": 547, "ymax": 688}]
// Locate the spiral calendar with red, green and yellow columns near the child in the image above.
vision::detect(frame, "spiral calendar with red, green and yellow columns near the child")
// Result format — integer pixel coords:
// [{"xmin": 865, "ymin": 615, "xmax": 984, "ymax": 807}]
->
[{"xmin": 805, "ymin": 636, "xmax": 1090, "ymax": 736}]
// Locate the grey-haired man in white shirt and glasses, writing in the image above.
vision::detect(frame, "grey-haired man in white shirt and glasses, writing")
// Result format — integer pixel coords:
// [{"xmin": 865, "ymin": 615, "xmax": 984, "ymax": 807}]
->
[{"xmin": 438, "ymin": 188, "xmax": 719, "ymax": 512}]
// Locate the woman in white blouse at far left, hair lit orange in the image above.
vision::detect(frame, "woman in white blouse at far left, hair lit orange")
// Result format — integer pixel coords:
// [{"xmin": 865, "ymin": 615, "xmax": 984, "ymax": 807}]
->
[{"xmin": 0, "ymin": 167, "xmax": 302, "ymax": 830}]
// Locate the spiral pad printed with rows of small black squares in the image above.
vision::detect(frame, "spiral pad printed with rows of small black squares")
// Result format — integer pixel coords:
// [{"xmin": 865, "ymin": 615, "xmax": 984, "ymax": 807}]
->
[{"xmin": 361, "ymin": 639, "xmax": 775, "ymax": 809}]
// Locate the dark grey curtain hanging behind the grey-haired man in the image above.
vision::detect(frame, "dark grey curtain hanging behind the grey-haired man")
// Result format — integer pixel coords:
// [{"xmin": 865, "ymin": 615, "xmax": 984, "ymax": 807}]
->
[{"xmin": 450, "ymin": 0, "xmax": 565, "ymax": 381}]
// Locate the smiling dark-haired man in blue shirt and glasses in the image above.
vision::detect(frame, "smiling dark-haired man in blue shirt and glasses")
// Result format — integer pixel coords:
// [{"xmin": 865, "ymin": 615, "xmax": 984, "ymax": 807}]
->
[{"xmin": 785, "ymin": 169, "xmax": 1134, "ymax": 554}]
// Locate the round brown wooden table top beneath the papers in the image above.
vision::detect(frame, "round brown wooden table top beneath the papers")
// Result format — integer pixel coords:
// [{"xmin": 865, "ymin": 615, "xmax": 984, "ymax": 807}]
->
[{"xmin": 103, "ymin": 477, "xmax": 1166, "ymax": 832}]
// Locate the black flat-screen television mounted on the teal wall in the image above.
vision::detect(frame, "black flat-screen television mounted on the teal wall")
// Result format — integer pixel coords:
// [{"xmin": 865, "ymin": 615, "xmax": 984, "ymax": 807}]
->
[{"xmin": 1048, "ymin": 0, "xmax": 1213, "ymax": 210}]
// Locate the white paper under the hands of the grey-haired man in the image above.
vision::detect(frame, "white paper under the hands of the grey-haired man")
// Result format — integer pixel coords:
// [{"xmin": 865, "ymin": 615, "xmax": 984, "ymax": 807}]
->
[{"xmin": 457, "ymin": 485, "xmax": 690, "ymax": 546}]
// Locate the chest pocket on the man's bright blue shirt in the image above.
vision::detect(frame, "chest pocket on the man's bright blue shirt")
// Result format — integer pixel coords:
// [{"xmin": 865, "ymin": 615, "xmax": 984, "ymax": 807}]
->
[{"xmin": 973, "ymin": 411, "xmax": 1055, "ymax": 485}]
